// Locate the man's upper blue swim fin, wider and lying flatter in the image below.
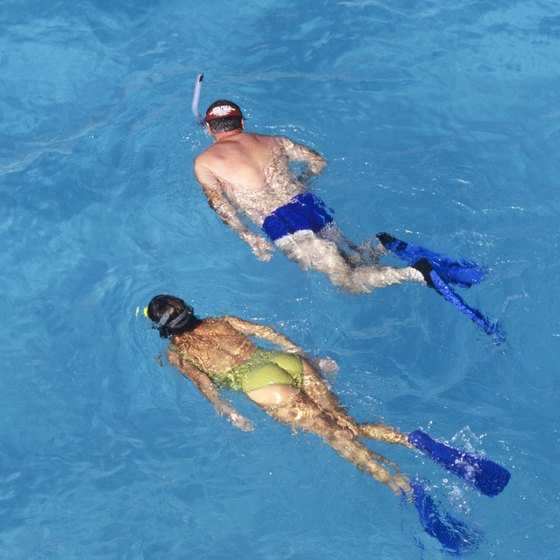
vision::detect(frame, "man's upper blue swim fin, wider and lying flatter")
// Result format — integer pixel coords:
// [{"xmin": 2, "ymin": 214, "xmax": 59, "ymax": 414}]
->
[{"xmin": 376, "ymin": 233, "xmax": 484, "ymax": 288}]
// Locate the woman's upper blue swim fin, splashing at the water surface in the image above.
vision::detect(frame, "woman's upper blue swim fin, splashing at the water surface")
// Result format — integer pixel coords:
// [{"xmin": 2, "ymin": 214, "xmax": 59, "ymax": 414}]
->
[{"xmin": 408, "ymin": 430, "xmax": 511, "ymax": 496}]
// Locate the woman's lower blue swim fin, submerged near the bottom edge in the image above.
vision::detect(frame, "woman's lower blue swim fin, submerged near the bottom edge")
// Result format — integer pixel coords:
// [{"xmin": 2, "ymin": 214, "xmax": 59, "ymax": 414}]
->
[{"xmin": 411, "ymin": 481, "xmax": 482, "ymax": 556}]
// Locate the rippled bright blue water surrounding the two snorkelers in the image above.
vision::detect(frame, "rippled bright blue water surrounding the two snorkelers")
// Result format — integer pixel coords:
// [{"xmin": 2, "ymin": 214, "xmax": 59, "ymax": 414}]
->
[{"xmin": 0, "ymin": 0, "xmax": 560, "ymax": 560}]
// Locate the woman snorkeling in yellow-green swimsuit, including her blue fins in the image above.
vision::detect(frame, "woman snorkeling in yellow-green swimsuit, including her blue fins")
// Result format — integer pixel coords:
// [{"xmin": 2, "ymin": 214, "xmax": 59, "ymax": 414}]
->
[{"xmin": 145, "ymin": 295, "xmax": 510, "ymax": 554}]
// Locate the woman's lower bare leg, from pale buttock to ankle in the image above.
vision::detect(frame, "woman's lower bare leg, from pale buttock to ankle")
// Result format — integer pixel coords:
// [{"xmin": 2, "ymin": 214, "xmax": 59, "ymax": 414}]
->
[{"xmin": 247, "ymin": 385, "xmax": 410, "ymax": 495}]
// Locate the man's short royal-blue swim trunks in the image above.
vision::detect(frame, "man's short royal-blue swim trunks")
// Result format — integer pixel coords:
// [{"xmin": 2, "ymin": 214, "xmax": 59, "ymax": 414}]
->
[{"xmin": 262, "ymin": 193, "xmax": 333, "ymax": 241}]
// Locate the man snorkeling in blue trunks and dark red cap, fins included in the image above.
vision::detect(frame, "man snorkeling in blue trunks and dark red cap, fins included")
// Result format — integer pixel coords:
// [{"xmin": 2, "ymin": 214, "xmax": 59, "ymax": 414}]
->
[{"xmin": 194, "ymin": 100, "xmax": 497, "ymax": 335}]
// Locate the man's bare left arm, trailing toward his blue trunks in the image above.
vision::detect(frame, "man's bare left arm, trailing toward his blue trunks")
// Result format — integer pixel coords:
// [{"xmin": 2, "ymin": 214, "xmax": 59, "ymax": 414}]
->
[{"xmin": 194, "ymin": 159, "xmax": 273, "ymax": 261}]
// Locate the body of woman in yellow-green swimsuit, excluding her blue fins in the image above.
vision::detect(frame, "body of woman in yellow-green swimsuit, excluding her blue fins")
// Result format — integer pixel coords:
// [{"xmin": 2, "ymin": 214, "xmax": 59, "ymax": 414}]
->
[{"xmin": 146, "ymin": 295, "xmax": 410, "ymax": 495}]
